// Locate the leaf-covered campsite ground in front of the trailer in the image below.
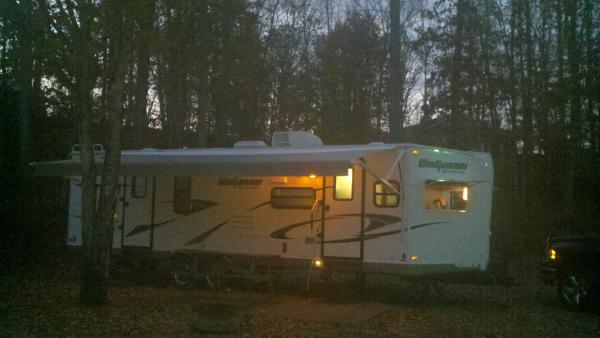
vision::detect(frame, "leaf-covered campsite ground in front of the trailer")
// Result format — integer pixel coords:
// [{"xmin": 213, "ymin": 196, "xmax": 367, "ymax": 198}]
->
[{"xmin": 0, "ymin": 261, "xmax": 600, "ymax": 337}]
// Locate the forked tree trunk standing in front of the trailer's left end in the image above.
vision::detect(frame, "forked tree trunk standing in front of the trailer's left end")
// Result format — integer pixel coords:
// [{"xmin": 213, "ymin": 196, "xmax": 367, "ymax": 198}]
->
[{"xmin": 80, "ymin": 0, "xmax": 133, "ymax": 305}]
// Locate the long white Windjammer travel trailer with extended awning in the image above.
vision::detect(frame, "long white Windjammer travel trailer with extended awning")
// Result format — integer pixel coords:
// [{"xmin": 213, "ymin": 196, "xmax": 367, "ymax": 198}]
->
[{"xmin": 33, "ymin": 131, "xmax": 493, "ymax": 286}]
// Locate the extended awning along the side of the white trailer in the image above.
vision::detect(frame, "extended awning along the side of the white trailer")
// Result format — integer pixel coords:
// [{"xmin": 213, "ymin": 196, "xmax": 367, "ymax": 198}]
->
[{"xmin": 31, "ymin": 144, "xmax": 398, "ymax": 176}]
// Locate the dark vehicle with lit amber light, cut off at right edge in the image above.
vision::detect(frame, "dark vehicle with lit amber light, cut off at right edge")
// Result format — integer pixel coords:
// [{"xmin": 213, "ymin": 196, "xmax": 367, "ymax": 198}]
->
[{"xmin": 542, "ymin": 235, "xmax": 600, "ymax": 310}]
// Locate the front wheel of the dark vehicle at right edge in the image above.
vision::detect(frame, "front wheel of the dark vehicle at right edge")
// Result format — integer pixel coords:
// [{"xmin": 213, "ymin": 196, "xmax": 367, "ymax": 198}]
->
[{"xmin": 558, "ymin": 271, "xmax": 591, "ymax": 311}]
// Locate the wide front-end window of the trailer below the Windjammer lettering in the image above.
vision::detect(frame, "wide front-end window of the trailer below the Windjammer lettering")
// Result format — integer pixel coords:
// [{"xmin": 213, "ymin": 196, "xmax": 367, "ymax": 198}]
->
[{"xmin": 425, "ymin": 181, "xmax": 471, "ymax": 212}]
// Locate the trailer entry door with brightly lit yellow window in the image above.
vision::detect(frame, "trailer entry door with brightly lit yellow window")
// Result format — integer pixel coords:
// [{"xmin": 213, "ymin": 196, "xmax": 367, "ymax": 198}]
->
[{"xmin": 323, "ymin": 170, "xmax": 361, "ymax": 259}]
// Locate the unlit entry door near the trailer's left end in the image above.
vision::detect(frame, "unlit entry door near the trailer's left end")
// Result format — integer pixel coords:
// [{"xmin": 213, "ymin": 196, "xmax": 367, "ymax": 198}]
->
[{"xmin": 121, "ymin": 177, "xmax": 153, "ymax": 247}]
